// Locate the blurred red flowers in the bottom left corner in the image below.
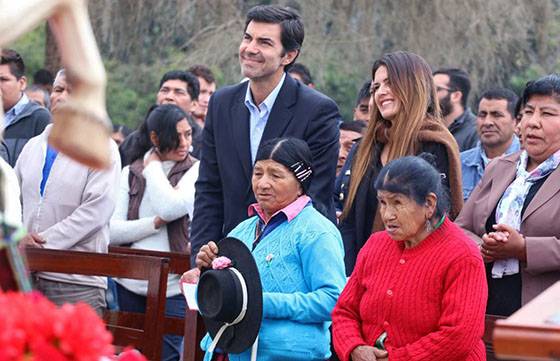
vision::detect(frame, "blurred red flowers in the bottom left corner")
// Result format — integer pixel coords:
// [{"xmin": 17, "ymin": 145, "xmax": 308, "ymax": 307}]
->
[{"xmin": 0, "ymin": 292, "xmax": 118, "ymax": 361}]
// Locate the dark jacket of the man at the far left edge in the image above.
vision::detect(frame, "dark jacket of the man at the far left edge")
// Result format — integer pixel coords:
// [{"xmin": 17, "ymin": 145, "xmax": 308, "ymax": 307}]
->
[{"xmin": 0, "ymin": 101, "xmax": 51, "ymax": 167}]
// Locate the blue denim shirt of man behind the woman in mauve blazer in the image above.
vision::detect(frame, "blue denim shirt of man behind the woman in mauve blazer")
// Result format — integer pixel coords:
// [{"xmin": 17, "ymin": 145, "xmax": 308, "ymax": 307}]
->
[{"xmin": 461, "ymin": 135, "xmax": 521, "ymax": 201}]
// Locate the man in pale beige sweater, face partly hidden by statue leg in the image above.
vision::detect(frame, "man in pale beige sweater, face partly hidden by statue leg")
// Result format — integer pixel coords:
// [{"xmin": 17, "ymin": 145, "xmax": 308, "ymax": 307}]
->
[{"xmin": 15, "ymin": 70, "xmax": 121, "ymax": 312}]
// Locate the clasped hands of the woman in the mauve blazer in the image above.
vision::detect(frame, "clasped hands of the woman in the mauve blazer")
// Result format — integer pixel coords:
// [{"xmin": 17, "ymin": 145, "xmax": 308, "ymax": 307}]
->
[{"xmin": 480, "ymin": 224, "xmax": 527, "ymax": 262}]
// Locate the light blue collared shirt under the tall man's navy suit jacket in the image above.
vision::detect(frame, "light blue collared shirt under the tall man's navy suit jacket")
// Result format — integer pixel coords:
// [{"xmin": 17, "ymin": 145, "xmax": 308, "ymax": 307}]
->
[{"xmin": 245, "ymin": 73, "xmax": 286, "ymax": 163}]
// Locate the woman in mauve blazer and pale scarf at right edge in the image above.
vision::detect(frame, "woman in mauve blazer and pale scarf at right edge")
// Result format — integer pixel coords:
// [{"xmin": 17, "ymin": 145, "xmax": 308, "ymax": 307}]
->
[{"xmin": 456, "ymin": 74, "xmax": 560, "ymax": 316}]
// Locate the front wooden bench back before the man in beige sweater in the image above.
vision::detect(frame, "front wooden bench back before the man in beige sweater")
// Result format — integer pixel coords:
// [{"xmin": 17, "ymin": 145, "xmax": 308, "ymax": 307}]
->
[{"xmin": 25, "ymin": 248, "xmax": 169, "ymax": 360}]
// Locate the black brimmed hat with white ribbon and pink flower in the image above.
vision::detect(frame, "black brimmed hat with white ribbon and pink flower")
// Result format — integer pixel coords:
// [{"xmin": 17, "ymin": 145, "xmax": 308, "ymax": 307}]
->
[{"xmin": 197, "ymin": 237, "xmax": 263, "ymax": 354}]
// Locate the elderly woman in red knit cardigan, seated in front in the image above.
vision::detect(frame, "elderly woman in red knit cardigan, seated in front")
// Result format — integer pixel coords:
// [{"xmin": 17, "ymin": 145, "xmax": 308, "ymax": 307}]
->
[{"xmin": 333, "ymin": 156, "xmax": 488, "ymax": 361}]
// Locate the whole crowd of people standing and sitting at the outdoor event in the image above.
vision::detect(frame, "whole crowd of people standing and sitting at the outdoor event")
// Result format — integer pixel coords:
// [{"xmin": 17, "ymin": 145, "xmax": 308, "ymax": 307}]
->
[{"xmin": 0, "ymin": 5, "xmax": 560, "ymax": 361}]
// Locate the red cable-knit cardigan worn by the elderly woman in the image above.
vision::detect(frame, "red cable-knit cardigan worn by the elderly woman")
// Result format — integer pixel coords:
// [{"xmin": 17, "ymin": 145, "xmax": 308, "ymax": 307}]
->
[{"xmin": 332, "ymin": 219, "xmax": 488, "ymax": 361}]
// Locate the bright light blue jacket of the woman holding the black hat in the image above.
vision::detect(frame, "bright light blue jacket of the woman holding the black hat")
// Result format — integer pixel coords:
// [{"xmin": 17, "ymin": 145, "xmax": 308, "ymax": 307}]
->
[{"xmin": 201, "ymin": 206, "xmax": 346, "ymax": 361}]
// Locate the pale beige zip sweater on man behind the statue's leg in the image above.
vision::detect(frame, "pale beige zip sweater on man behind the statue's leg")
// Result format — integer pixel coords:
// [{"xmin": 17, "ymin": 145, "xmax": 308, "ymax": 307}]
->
[{"xmin": 15, "ymin": 125, "xmax": 121, "ymax": 288}]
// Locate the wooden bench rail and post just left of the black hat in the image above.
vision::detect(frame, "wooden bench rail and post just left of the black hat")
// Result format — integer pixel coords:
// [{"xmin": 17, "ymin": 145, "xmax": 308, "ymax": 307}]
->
[{"xmin": 109, "ymin": 246, "xmax": 206, "ymax": 361}]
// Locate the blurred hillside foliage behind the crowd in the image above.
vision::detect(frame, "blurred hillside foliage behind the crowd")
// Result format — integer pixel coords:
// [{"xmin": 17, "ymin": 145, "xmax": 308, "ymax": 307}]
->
[{"xmin": 7, "ymin": 0, "xmax": 560, "ymax": 128}]
